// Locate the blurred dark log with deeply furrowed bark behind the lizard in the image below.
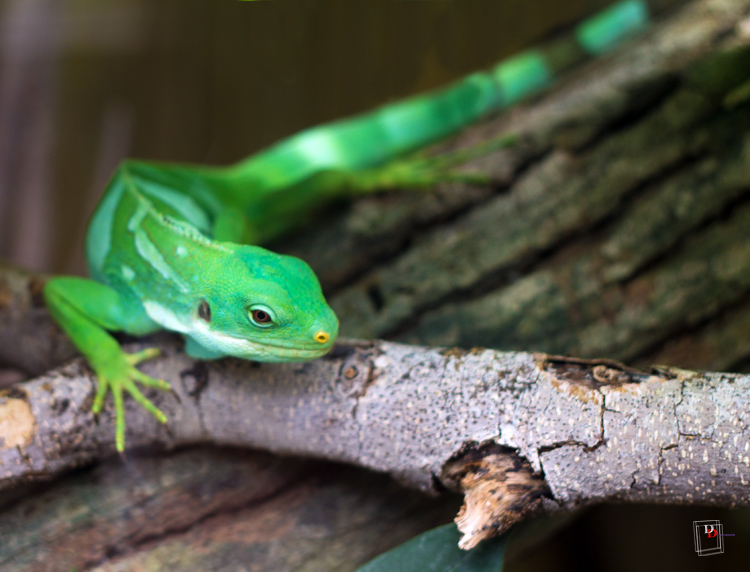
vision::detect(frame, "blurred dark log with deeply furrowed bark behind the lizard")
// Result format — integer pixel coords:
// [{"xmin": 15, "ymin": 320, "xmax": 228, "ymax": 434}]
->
[{"xmin": 284, "ymin": 1, "xmax": 750, "ymax": 369}]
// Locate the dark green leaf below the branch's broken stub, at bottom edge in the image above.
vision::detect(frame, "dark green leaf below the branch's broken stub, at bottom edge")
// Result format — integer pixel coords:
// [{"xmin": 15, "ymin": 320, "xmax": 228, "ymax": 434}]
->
[{"xmin": 356, "ymin": 523, "xmax": 507, "ymax": 572}]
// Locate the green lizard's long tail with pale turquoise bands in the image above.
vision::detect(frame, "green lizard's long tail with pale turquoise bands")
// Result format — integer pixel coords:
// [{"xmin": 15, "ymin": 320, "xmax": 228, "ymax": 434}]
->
[{"xmin": 227, "ymin": 0, "xmax": 650, "ymax": 196}]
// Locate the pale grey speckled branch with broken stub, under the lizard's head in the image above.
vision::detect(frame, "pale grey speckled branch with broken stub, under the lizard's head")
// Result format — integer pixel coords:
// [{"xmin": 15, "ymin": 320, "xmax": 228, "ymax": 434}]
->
[{"xmin": 0, "ymin": 332, "xmax": 750, "ymax": 545}]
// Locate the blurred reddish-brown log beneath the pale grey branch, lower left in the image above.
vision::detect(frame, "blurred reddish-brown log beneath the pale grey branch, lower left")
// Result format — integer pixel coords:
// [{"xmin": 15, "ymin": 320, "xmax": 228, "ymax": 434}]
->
[{"xmin": 0, "ymin": 448, "xmax": 459, "ymax": 572}]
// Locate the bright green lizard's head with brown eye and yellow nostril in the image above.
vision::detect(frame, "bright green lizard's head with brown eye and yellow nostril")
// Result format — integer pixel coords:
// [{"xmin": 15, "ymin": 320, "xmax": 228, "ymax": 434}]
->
[{"xmin": 190, "ymin": 245, "xmax": 339, "ymax": 362}]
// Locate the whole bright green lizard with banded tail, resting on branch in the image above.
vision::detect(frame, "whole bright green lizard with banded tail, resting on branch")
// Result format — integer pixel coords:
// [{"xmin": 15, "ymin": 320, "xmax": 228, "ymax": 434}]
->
[{"xmin": 44, "ymin": 0, "xmax": 648, "ymax": 451}]
